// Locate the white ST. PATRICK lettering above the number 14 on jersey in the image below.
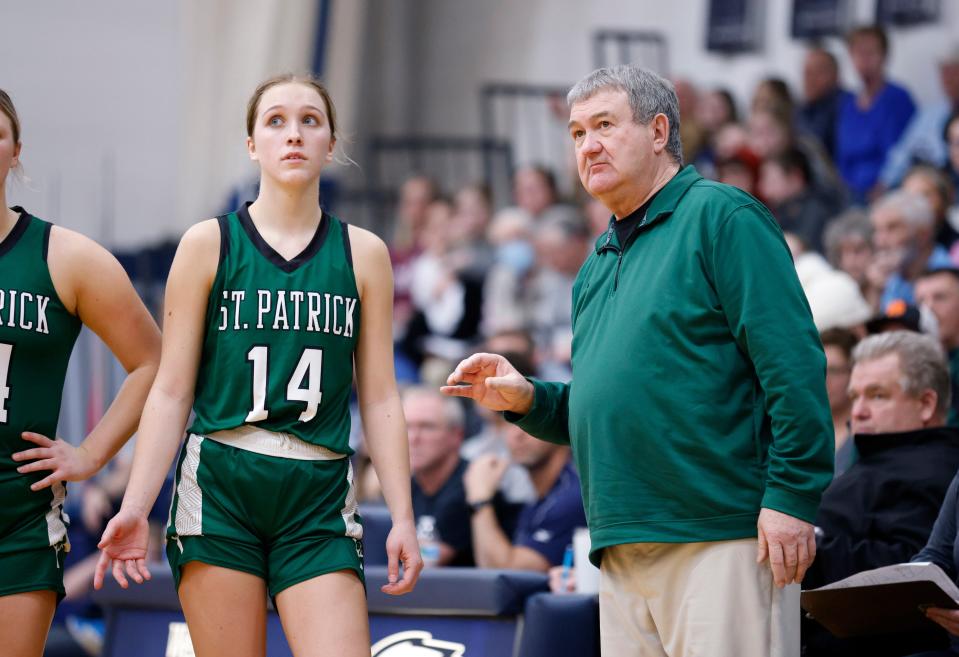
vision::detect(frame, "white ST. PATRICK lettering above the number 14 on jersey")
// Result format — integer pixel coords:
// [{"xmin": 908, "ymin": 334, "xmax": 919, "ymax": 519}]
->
[{"xmin": 217, "ymin": 290, "xmax": 356, "ymax": 338}]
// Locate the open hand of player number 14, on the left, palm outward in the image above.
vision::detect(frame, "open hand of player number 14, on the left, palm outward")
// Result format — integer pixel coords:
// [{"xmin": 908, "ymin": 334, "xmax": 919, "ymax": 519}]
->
[{"xmin": 93, "ymin": 508, "xmax": 150, "ymax": 590}]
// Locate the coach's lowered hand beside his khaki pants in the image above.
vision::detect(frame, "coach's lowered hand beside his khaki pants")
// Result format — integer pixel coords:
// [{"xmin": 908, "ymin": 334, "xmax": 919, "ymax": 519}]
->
[{"xmin": 756, "ymin": 509, "xmax": 816, "ymax": 588}]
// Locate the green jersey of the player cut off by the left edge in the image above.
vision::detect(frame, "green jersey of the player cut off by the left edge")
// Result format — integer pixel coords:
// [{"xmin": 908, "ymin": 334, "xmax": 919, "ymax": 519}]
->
[{"xmin": 0, "ymin": 207, "xmax": 80, "ymax": 472}]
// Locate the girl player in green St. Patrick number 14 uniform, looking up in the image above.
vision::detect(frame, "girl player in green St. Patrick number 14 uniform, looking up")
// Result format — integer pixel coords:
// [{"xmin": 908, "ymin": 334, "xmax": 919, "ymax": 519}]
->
[{"xmin": 96, "ymin": 76, "xmax": 422, "ymax": 657}]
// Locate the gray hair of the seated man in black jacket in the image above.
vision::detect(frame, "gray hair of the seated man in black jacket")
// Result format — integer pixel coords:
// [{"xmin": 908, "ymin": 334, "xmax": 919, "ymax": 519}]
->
[{"xmin": 852, "ymin": 331, "xmax": 951, "ymax": 417}]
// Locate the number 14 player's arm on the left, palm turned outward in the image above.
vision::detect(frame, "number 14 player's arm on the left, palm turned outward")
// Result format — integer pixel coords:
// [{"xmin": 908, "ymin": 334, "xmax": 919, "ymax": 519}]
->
[{"xmin": 94, "ymin": 220, "xmax": 220, "ymax": 588}]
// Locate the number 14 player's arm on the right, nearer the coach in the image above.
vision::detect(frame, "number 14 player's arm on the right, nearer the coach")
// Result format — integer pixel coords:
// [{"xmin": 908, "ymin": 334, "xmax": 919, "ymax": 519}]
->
[{"xmin": 349, "ymin": 226, "xmax": 423, "ymax": 595}]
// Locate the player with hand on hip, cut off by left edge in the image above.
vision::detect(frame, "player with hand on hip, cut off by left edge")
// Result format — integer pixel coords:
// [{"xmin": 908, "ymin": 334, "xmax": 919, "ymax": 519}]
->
[{"xmin": 0, "ymin": 90, "xmax": 160, "ymax": 657}]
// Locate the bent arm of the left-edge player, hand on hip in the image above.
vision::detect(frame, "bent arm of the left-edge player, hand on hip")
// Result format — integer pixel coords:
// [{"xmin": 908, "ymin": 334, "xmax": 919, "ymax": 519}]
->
[{"xmin": 14, "ymin": 226, "xmax": 160, "ymax": 490}]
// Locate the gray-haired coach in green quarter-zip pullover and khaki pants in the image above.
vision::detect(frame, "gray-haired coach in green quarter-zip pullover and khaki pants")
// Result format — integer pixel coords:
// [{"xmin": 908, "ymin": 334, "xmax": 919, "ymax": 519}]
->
[{"xmin": 443, "ymin": 66, "xmax": 833, "ymax": 657}]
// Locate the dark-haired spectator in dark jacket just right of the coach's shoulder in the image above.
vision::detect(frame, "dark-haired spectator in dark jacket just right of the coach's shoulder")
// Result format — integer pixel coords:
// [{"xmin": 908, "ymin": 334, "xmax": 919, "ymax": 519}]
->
[{"xmin": 759, "ymin": 148, "xmax": 832, "ymax": 253}]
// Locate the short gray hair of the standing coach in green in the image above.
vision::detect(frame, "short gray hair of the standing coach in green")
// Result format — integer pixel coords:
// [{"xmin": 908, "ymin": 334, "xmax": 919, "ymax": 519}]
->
[{"xmin": 566, "ymin": 64, "xmax": 683, "ymax": 167}]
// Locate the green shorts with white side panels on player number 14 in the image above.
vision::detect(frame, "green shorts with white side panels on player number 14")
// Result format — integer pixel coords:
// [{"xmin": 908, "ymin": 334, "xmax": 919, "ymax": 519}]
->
[{"xmin": 166, "ymin": 430, "xmax": 363, "ymax": 597}]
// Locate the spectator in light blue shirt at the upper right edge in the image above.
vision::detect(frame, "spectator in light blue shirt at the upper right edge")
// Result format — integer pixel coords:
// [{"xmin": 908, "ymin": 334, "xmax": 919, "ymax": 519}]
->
[{"xmin": 879, "ymin": 45, "xmax": 959, "ymax": 189}]
